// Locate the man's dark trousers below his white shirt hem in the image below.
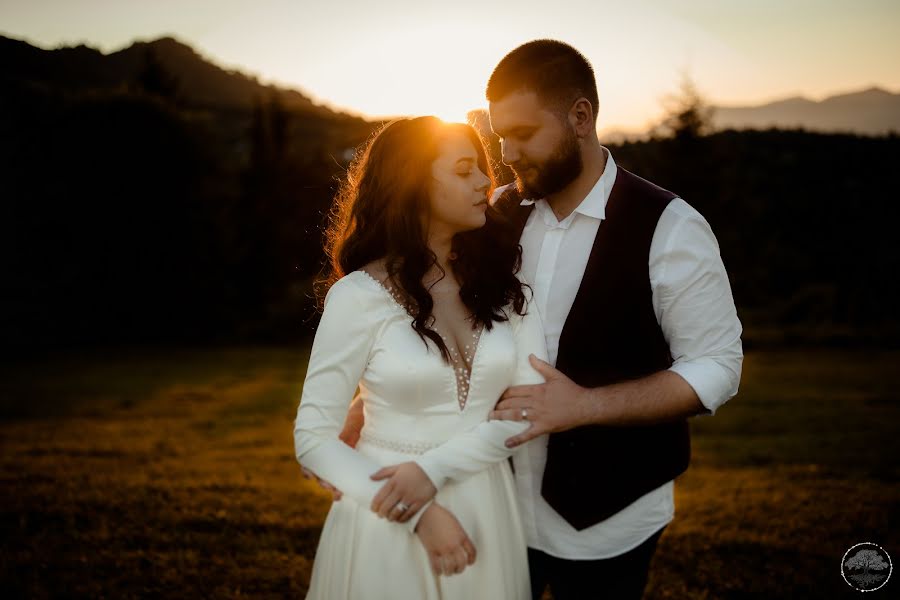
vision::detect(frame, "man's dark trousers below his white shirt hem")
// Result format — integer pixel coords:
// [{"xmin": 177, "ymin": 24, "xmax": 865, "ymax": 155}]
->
[{"xmin": 528, "ymin": 525, "xmax": 668, "ymax": 600}]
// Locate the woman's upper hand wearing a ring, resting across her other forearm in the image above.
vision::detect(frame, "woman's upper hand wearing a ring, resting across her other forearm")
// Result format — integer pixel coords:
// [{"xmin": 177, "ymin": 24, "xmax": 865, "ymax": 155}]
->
[{"xmin": 372, "ymin": 462, "xmax": 437, "ymax": 523}]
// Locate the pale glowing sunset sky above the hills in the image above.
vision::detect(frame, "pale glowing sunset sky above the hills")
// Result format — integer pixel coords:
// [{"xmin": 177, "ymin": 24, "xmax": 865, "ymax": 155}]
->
[{"xmin": 0, "ymin": 0, "xmax": 900, "ymax": 129}]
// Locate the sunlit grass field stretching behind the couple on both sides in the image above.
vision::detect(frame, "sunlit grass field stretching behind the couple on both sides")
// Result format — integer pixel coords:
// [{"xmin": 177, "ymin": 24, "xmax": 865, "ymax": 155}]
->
[{"xmin": 0, "ymin": 348, "xmax": 900, "ymax": 599}]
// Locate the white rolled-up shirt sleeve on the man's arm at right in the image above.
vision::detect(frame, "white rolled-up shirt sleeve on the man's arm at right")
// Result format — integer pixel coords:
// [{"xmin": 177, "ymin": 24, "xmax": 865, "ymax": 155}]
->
[{"xmin": 649, "ymin": 198, "xmax": 744, "ymax": 415}]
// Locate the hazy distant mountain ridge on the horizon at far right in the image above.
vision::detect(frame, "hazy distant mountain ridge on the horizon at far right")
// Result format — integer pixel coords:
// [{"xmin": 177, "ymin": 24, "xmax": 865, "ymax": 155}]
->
[{"xmin": 713, "ymin": 87, "xmax": 900, "ymax": 135}]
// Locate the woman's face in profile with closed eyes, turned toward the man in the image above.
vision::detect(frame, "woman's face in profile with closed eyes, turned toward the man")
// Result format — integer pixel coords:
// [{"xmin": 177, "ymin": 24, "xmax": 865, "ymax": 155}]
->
[{"xmin": 428, "ymin": 132, "xmax": 491, "ymax": 234}]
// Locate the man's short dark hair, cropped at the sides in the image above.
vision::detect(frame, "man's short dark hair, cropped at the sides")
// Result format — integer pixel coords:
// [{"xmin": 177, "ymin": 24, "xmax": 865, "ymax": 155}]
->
[{"xmin": 485, "ymin": 40, "xmax": 599, "ymax": 124}]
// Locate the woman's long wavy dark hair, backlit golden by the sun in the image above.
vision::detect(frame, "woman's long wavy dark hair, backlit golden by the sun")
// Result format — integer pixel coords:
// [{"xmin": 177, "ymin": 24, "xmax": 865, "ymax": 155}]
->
[{"xmin": 317, "ymin": 117, "xmax": 525, "ymax": 362}]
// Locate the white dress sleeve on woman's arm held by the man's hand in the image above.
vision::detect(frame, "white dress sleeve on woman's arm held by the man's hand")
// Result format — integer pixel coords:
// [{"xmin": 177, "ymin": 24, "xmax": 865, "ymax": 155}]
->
[{"xmin": 416, "ymin": 290, "xmax": 547, "ymax": 489}]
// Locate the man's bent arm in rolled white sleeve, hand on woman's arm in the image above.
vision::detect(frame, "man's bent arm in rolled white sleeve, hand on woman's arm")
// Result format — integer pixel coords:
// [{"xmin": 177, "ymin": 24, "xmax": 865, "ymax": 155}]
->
[{"xmin": 491, "ymin": 199, "xmax": 743, "ymax": 446}]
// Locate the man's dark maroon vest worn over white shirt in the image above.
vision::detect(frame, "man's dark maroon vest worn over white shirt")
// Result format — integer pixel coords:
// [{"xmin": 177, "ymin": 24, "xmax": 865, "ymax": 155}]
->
[{"xmin": 497, "ymin": 167, "xmax": 691, "ymax": 530}]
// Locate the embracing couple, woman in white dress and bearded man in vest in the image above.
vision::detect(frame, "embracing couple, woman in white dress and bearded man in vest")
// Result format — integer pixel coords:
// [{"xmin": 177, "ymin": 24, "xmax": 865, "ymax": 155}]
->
[{"xmin": 294, "ymin": 40, "xmax": 743, "ymax": 600}]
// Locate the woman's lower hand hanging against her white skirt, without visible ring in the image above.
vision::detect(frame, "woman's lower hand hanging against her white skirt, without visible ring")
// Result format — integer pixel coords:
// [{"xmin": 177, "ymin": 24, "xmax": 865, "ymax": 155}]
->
[{"xmin": 416, "ymin": 502, "xmax": 475, "ymax": 575}]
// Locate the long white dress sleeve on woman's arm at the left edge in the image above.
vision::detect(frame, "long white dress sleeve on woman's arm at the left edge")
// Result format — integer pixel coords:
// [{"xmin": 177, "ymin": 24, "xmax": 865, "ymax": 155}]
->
[{"xmin": 294, "ymin": 278, "xmax": 408, "ymax": 524}]
